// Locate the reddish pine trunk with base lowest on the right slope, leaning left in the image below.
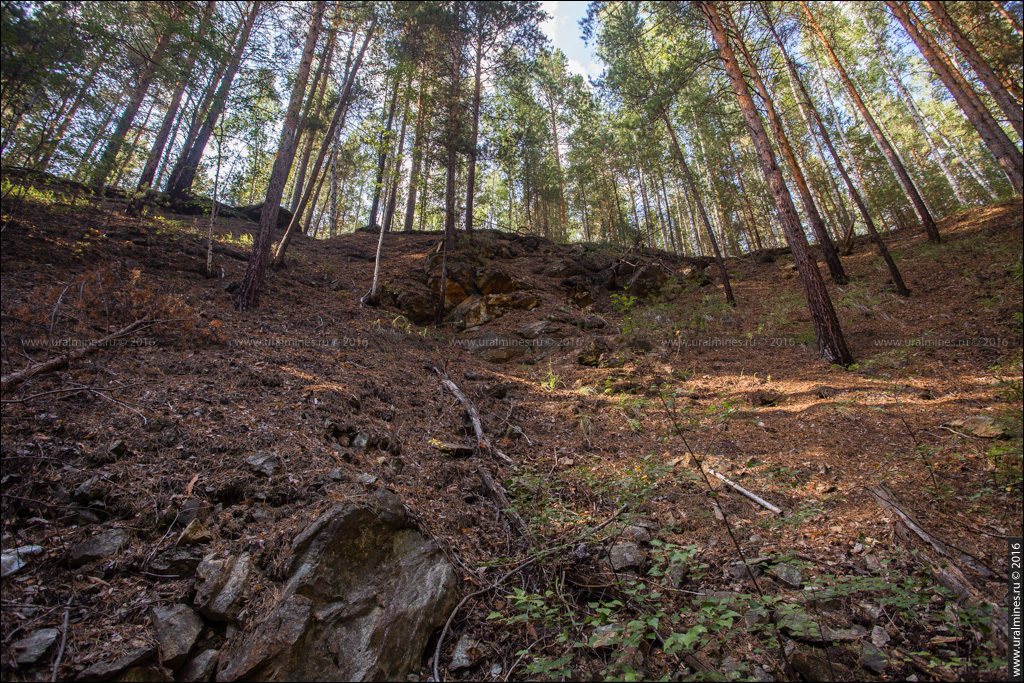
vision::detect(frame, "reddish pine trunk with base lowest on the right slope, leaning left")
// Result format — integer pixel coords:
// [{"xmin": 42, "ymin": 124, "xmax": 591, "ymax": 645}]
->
[{"xmin": 700, "ymin": 2, "xmax": 853, "ymax": 366}]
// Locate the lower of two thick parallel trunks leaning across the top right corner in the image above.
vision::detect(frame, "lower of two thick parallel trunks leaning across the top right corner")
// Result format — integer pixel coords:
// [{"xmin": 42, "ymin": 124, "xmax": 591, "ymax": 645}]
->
[{"xmin": 886, "ymin": 0, "xmax": 1024, "ymax": 195}]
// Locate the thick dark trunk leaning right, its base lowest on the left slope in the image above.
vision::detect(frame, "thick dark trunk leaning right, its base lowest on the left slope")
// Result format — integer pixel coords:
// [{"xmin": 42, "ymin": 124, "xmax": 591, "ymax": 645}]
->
[{"xmin": 234, "ymin": 0, "xmax": 327, "ymax": 311}]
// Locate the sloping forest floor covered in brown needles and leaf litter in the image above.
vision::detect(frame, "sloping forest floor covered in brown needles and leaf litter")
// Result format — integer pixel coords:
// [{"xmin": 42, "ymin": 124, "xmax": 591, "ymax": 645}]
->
[{"xmin": 2, "ymin": 181, "xmax": 1022, "ymax": 680}]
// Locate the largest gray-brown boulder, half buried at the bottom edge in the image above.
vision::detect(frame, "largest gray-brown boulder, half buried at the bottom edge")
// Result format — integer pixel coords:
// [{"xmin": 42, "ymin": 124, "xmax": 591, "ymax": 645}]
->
[{"xmin": 217, "ymin": 505, "xmax": 458, "ymax": 681}]
